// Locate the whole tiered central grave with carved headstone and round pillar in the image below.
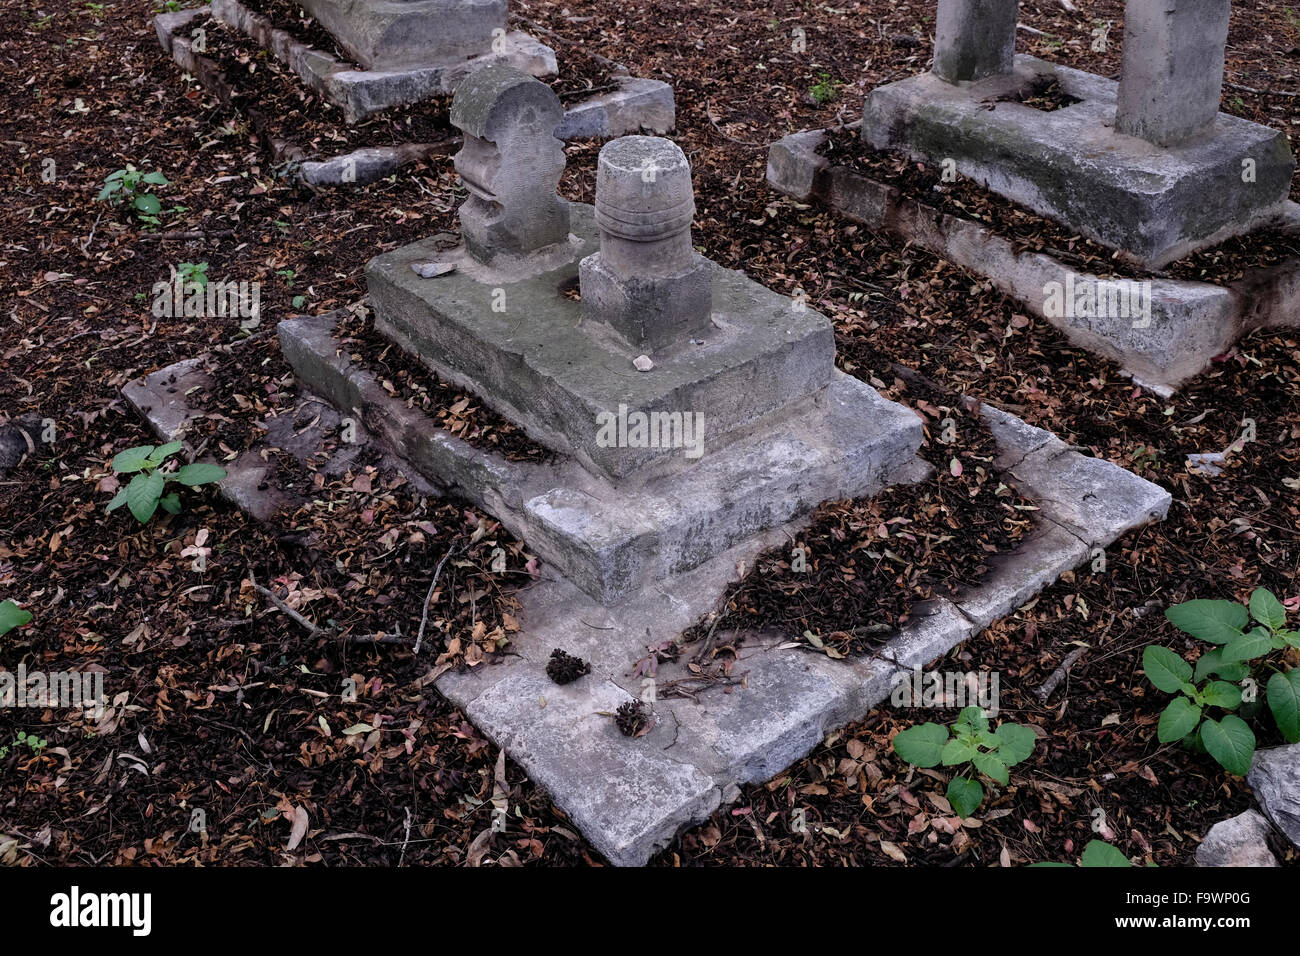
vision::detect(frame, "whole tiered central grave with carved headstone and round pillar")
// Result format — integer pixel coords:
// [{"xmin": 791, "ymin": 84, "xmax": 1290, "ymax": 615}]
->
[{"xmin": 261, "ymin": 66, "xmax": 1169, "ymax": 865}]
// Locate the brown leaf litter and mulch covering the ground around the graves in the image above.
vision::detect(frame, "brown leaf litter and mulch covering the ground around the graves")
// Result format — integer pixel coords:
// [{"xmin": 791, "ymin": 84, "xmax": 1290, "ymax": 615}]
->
[{"xmin": 0, "ymin": 0, "xmax": 1300, "ymax": 866}]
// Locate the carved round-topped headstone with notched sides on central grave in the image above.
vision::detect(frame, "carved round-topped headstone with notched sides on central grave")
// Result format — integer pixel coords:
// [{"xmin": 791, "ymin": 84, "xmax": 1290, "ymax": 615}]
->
[{"xmin": 451, "ymin": 65, "xmax": 569, "ymax": 265}]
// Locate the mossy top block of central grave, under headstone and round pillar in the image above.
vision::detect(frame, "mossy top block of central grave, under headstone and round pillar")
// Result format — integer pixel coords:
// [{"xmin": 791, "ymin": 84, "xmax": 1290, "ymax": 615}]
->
[{"xmin": 367, "ymin": 203, "xmax": 835, "ymax": 477}]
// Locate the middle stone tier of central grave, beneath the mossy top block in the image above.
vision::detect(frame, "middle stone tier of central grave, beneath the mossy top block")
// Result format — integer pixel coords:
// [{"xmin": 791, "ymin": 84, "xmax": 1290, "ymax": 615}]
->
[{"xmin": 280, "ymin": 310, "xmax": 922, "ymax": 602}]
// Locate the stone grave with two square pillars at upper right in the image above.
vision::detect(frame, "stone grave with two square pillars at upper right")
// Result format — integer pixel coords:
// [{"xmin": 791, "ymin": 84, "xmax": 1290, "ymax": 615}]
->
[{"xmin": 768, "ymin": 0, "xmax": 1300, "ymax": 392}]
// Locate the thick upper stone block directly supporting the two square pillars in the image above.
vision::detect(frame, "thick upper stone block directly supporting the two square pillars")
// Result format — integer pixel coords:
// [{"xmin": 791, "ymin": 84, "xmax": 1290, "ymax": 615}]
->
[{"xmin": 862, "ymin": 56, "xmax": 1295, "ymax": 268}]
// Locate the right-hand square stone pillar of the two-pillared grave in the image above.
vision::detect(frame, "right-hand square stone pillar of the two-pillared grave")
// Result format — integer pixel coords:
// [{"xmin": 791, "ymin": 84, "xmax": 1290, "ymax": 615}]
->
[{"xmin": 1115, "ymin": 0, "xmax": 1231, "ymax": 146}]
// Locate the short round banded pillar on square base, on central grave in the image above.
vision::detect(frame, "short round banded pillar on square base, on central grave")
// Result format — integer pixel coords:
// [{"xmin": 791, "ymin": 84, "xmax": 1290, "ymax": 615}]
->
[{"xmin": 579, "ymin": 137, "xmax": 712, "ymax": 349}]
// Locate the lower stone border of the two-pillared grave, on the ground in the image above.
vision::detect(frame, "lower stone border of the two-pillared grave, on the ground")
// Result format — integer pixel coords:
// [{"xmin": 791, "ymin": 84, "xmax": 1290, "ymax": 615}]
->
[{"xmin": 767, "ymin": 123, "xmax": 1300, "ymax": 395}]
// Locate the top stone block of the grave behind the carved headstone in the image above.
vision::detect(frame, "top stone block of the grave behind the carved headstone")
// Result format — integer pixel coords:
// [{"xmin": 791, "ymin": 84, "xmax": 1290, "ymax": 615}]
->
[{"xmin": 299, "ymin": 0, "xmax": 506, "ymax": 70}]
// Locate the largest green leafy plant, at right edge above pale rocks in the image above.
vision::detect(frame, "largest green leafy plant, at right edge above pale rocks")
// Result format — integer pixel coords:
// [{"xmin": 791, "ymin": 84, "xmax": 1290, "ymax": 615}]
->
[{"xmin": 1141, "ymin": 588, "xmax": 1300, "ymax": 777}]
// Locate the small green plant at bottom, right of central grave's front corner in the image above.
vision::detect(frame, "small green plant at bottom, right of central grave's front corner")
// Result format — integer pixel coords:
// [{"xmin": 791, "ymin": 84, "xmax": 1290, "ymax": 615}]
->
[{"xmin": 893, "ymin": 708, "xmax": 1037, "ymax": 818}]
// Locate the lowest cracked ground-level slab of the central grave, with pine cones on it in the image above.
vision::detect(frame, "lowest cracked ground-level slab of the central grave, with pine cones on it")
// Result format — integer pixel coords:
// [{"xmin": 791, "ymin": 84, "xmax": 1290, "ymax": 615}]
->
[{"xmin": 126, "ymin": 345, "xmax": 1170, "ymax": 865}]
